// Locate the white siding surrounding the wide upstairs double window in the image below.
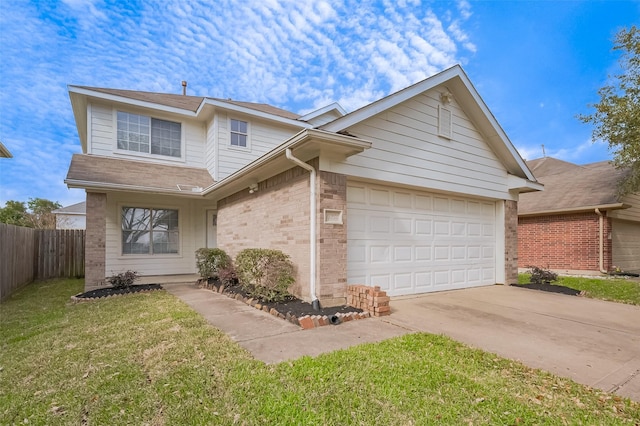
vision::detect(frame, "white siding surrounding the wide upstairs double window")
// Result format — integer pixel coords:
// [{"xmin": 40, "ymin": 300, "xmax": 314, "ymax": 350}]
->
[{"xmin": 87, "ymin": 103, "xmax": 206, "ymax": 167}]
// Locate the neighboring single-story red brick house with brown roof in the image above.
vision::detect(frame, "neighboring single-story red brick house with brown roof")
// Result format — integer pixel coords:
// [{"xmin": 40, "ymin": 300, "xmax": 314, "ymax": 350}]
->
[{"xmin": 518, "ymin": 157, "xmax": 640, "ymax": 273}]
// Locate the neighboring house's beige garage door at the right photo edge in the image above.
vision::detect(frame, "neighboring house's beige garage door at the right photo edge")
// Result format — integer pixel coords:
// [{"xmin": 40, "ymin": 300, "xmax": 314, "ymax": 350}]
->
[{"xmin": 611, "ymin": 220, "xmax": 640, "ymax": 273}]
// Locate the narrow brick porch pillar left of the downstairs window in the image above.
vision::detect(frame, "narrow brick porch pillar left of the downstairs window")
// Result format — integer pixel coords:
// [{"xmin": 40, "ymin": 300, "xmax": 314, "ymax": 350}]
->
[{"xmin": 84, "ymin": 192, "xmax": 107, "ymax": 291}]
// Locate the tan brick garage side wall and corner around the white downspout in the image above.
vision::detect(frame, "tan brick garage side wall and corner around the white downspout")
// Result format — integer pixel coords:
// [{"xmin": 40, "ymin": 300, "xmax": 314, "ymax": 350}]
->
[{"xmin": 218, "ymin": 162, "xmax": 347, "ymax": 307}]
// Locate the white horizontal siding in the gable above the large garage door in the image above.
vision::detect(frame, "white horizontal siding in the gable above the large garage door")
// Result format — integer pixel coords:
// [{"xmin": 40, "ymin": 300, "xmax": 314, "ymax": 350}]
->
[{"xmin": 321, "ymin": 90, "xmax": 513, "ymax": 199}]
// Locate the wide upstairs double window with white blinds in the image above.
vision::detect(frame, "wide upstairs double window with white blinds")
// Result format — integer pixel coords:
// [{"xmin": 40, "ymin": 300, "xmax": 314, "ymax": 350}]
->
[{"xmin": 118, "ymin": 111, "xmax": 182, "ymax": 158}]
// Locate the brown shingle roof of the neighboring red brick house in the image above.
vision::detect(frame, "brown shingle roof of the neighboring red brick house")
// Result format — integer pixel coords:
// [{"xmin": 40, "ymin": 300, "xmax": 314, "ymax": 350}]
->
[{"xmin": 518, "ymin": 157, "xmax": 627, "ymax": 215}]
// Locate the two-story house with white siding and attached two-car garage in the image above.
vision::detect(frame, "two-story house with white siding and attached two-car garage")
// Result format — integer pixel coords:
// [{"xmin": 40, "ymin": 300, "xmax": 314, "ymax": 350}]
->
[{"xmin": 65, "ymin": 66, "xmax": 542, "ymax": 306}]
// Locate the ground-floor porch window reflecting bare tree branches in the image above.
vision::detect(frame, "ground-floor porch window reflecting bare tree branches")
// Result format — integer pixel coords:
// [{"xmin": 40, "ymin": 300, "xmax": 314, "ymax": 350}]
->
[{"xmin": 122, "ymin": 207, "xmax": 180, "ymax": 255}]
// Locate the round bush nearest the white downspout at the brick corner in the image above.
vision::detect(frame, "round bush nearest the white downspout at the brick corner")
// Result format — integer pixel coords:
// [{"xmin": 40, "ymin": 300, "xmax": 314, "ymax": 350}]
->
[{"xmin": 235, "ymin": 249, "xmax": 295, "ymax": 302}]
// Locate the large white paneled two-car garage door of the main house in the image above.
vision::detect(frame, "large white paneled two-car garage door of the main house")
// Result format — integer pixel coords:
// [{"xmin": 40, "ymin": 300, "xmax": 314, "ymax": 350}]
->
[{"xmin": 347, "ymin": 183, "xmax": 496, "ymax": 296}]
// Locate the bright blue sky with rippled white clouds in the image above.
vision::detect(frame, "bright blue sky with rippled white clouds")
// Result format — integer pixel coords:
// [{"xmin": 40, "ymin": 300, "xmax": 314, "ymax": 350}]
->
[{"xmin": 0, "ymin": 0, "xmax": 640, "ymax": 207}]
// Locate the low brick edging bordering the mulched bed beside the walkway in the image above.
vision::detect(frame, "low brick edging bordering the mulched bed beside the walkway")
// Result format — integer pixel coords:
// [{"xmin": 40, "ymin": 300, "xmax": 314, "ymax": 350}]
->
[{"xmin": 196, "ymin": 280, "xmax": 376, "ymax": 330}]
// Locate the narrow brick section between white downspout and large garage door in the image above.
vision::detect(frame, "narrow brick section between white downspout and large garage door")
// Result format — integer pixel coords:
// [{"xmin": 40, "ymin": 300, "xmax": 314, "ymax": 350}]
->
[{"xmin": 316, "ymin": 172, "xmax": 347, "ymax": 307}]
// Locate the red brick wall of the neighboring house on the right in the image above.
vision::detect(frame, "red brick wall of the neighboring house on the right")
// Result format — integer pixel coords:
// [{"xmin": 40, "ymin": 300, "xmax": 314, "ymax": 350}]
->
[{"xmin": 518, "ymin": 212, "xmax": 612, "ymax": 271}]
